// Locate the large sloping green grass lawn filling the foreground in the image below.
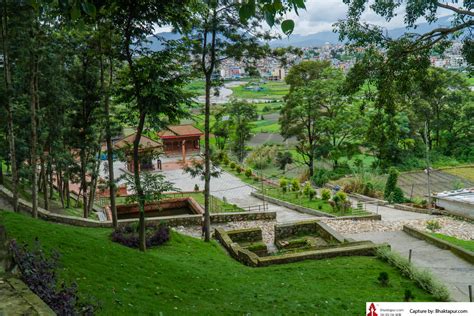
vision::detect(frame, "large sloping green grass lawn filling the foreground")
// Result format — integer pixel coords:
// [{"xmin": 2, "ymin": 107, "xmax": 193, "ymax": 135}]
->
[{"xmin": 0, "ymin": 212, "xmax": 433, "ymax": 315}]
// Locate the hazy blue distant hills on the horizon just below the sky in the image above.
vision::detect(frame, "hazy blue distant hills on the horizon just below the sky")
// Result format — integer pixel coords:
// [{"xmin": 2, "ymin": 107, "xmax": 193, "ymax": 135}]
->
[{"xmin": 148, "ymin": 16, "xmax": 451, "ymax": 50}]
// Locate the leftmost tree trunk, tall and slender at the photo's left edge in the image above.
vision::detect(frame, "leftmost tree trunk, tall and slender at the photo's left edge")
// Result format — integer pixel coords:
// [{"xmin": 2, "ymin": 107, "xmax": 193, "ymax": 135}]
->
[{"xmin": 2, "ymin": 0, "xmax": 18, "ymax": 212}]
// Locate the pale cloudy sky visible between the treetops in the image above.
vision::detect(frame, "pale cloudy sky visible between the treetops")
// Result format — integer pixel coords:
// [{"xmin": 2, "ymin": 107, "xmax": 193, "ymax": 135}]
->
[{"xmin": 156, "ymin": 0, "xmax": 451, "ymax": 35}]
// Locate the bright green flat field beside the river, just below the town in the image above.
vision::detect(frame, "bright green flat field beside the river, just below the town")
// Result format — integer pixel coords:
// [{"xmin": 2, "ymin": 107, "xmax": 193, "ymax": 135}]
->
[{"xmin": 231, "ymin": 81, "xmax": 289, "ymax": 99}]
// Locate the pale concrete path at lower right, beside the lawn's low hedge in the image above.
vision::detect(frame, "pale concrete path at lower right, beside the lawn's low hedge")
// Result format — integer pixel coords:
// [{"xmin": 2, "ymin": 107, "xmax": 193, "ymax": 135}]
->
[{"xmin": 347, "ymin": 231, "xmax": 474, "ymax": 302}]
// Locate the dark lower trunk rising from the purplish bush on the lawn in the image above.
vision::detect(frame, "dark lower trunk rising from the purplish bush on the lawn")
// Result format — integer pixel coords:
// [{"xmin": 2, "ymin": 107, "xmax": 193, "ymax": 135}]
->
[{"xmin": 133, "ymin": 108, "xmax": 146, "ymax": 251}]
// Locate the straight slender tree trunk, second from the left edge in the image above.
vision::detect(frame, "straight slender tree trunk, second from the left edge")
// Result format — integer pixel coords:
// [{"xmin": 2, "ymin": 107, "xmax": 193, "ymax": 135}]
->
[{"xmin": 30, "ymin": 52, "xmax": 38, "ymax": 218}]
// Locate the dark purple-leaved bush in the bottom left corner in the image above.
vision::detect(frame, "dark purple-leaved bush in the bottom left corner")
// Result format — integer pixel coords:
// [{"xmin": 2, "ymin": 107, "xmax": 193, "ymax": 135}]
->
[{"xmin": 9, "ymin": 240, "xmax": 98, "ymax": 315}]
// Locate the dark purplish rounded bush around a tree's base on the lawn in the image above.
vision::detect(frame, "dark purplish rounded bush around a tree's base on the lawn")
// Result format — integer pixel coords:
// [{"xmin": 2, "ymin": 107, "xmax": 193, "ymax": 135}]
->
[{"xmin": 111, "ymin": 223, "xmax": 170, "ymax": 248}]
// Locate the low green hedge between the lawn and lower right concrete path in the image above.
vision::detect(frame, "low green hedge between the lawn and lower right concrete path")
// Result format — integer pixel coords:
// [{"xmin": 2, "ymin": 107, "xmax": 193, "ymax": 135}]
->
[{"xmin": 377, "ymin": 247, "xmax": 449, "ymax": 302}]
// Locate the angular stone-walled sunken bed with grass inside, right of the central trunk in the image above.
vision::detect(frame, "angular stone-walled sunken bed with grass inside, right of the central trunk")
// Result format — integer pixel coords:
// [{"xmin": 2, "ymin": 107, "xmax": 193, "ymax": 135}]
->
[{"xmin": 215, "ymin": 221, "xmax": 386, "ymax": 267}]
